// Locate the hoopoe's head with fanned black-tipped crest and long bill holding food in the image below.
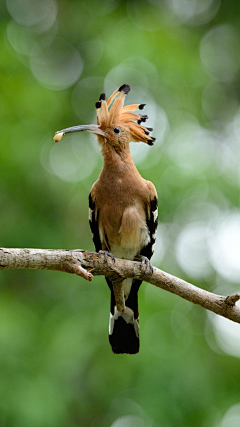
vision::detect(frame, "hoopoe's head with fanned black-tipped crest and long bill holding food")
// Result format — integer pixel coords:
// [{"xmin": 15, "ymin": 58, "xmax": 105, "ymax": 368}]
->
[{"xmin": 54, "ymin": 84, "xmax": 156, "ymax": 149}]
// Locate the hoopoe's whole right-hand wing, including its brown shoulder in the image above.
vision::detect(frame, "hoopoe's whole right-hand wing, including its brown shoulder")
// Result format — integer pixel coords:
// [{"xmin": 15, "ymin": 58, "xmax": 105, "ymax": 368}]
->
[{"xmin": 140, "ymin": 181, "xmax": 158, "ymax": 259}]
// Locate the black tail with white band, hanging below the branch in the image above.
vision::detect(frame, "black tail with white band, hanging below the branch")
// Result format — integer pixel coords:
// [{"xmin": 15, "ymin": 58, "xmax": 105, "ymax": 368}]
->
[{"xmin": 106, "ymin": 278, "xmax": 142, "ymax": 354}]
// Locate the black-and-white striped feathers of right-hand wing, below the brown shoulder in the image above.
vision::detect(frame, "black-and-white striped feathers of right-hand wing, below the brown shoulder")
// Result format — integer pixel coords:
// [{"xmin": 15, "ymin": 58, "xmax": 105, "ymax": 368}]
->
[{"xmin": 140, "ymin": 196, "xmax": 158, "ymax": 259}]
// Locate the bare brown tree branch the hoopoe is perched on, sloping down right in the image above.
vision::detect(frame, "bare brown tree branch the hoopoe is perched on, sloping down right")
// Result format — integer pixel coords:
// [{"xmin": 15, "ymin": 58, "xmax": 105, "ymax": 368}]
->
[{"xmin": 0, "ymin": 248, "xmax": 240, "ymax": 323}]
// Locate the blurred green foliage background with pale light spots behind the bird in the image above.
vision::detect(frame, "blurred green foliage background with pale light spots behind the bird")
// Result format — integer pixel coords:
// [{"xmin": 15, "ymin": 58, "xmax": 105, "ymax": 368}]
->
[{"xmin": 0, "ymin": 0, "xmax": 240, "ymax": 427}]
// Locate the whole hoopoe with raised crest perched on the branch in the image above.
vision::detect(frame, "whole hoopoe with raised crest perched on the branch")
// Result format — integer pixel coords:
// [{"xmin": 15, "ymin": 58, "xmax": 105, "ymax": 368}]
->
[{"xmin": 54, "ymin": 84, "xmax": 158, "ymax": 354}]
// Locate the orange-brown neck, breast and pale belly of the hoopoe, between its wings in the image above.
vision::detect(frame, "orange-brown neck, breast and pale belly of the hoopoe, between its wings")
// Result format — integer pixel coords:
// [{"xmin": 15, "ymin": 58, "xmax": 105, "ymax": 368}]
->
[{"xmin": 91, "ymin": 147, "xmax": 151, "ymax": 259}]
